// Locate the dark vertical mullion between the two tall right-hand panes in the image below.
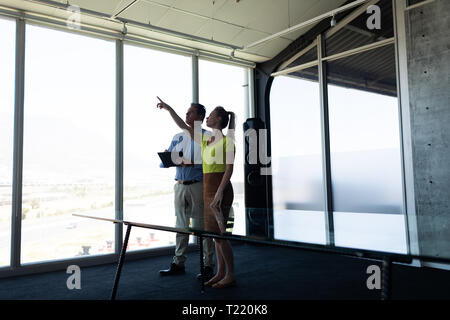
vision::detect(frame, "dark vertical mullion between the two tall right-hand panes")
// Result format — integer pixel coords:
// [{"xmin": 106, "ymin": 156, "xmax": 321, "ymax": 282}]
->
[{"xmin": 317, "ymin": 34, "xmax": 334, "ymax": 246}]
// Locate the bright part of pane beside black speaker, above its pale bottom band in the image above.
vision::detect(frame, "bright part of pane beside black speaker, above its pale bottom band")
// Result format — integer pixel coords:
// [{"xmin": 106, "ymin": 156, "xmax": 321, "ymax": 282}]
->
[{"xmin": 270, "ymin": 69, "xmax": 324, "ymax": 211}]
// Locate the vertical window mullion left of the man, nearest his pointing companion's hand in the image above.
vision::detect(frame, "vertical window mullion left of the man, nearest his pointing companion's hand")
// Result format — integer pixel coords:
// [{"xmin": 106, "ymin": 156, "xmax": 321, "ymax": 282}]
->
[{"xmin": 114, "ymin": 40, "xmax": 124, "ymax": 254}]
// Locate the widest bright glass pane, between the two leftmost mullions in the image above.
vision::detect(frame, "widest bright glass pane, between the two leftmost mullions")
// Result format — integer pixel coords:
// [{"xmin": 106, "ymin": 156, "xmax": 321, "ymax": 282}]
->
[{"xmin": 21, "ymin": 25, "xmax": 115, "ymax": 263}]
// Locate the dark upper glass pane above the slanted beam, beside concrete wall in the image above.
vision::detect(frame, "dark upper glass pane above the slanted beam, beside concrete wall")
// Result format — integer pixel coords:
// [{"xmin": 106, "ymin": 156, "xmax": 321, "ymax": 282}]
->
[{"xmin": 326, "ymin": 0, "xmax": 394, "ymax": 56}]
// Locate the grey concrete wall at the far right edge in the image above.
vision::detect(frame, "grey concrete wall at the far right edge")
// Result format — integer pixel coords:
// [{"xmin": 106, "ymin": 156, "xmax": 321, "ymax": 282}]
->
[{"xmin": 404, "ymin": 0, "xmax": 450, "ymax": 257}]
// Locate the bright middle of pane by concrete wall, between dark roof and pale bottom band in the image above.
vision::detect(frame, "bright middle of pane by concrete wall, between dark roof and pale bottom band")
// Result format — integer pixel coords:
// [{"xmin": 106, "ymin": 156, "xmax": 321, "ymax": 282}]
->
[{"xmin": 328, "ymin": 85, "xmax": 402, "ymax": 214}]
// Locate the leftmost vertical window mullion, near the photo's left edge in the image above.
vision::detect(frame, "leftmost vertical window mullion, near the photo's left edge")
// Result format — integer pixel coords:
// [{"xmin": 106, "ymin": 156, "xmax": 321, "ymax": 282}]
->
[{"xmin": 10, "ymin": 19, "xmax": 25, "ymax": 269}]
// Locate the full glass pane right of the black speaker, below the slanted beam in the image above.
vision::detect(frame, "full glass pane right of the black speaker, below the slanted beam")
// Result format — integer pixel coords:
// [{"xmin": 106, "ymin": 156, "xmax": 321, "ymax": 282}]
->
[{"xmin": 270, "ymin": 67, "xmax": 326, "ymax": 244}]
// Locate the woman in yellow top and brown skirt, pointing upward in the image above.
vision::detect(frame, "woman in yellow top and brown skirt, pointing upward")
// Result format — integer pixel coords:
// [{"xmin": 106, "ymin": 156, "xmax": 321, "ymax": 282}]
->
[{"xmin": 157, "ymin": 97, "xmax": 236, "ymax": 288}]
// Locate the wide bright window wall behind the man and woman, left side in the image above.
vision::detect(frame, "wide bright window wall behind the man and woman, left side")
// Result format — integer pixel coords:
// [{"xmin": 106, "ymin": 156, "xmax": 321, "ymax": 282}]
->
[{"xmin": 0, "ymin": 20, "xmax": 250, "ymax": 266}]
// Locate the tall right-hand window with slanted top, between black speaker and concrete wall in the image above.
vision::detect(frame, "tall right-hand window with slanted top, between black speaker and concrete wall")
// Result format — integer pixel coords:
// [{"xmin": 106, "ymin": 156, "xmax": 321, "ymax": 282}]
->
[{"xmin": 270, "ymin": 0, "xmax": 408, "ymax": 253}]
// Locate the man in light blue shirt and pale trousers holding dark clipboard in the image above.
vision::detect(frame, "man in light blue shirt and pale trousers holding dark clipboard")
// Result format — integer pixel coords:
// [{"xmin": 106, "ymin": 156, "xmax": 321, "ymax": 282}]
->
[{"xmin": 159, "ymin": 103, "xmax": 214, "ymax": 280}]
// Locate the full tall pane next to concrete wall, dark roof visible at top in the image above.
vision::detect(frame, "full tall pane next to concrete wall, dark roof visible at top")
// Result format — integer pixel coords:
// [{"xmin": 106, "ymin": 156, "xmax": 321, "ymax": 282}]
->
[{"xmin": 328, "ymin": 46, "xmax": 407, "ymax": 253}]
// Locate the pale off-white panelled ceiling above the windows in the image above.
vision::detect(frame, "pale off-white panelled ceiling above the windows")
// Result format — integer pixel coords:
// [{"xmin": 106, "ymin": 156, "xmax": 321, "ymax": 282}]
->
[{"xmin": 0, "ymin": 0, "xmax": 352, "ymax": 61}]
